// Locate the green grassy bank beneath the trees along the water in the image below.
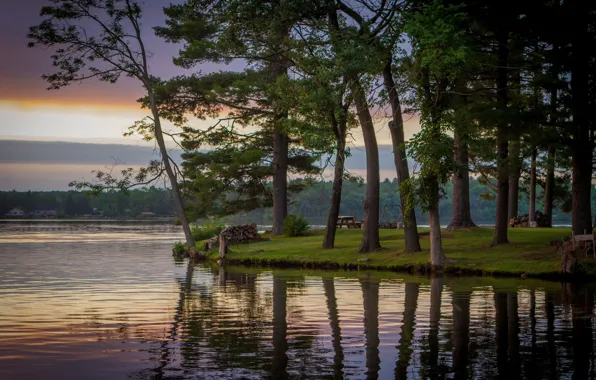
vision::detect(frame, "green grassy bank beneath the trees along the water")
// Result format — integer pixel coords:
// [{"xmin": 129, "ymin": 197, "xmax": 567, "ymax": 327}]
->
[{"xmin": 210, "ymin": 228, "xmax": 596, "ymax": 278}]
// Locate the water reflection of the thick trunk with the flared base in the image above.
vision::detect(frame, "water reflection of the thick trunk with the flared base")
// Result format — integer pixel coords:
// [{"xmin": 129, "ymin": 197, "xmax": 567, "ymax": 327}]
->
[{"xmin": 452, "ymin": 292, "xmax": 472, "ymax": 379}]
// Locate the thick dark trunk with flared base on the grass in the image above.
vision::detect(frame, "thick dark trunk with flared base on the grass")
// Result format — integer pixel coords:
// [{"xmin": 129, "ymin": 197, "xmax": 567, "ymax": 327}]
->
[{"xmin": 447, "ymin": 128, "xmax": 476, "ymax": 231}]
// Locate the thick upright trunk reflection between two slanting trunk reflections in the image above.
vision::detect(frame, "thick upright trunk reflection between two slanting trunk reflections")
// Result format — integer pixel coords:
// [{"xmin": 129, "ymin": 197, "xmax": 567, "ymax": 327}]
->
[{"xmin": 360, "ymin": 278, "xmax": 381, "ymax": 379}]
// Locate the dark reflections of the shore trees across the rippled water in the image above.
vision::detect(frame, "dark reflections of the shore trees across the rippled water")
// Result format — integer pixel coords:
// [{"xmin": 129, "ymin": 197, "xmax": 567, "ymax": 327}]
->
[{"xmin": 132, "ymin": 267, "xmax": 594, "ymax": 379}]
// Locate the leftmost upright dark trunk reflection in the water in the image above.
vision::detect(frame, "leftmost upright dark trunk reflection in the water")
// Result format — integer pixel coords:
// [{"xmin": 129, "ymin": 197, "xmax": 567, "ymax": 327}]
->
[{"xmin": 271, "ymin": 275, "xmax": 288, "ymax": 379}]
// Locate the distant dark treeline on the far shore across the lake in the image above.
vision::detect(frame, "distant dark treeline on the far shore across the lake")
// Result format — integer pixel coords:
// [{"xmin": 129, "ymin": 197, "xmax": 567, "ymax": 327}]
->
[{"xmin": 0, "ymin": 178, "xmax": 584, "ymax": 224}]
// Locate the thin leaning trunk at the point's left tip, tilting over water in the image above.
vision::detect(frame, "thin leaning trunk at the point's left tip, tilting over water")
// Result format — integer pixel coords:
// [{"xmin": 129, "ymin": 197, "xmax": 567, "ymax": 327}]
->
[{"xmin": 145, "ymin": 91, "xmax": 195, "ymax": 249}]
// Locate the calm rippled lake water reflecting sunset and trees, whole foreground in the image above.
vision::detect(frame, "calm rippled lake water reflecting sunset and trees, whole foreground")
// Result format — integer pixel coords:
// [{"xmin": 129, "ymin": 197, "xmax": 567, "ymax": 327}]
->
[{"xmin": 0, "ymin": 222, "xmax": 596, "ymax": 380}]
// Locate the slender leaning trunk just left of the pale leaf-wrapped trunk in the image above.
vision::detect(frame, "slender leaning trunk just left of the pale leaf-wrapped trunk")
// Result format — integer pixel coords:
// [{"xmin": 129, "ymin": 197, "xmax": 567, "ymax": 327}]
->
[{"xmin": 383, "ymin": 59, "xmax": 422, "ymax": 252}]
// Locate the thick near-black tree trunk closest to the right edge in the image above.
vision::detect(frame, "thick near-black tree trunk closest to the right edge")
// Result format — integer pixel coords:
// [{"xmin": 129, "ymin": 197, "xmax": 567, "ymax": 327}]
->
[{"xmin": 570, "ymin": 0, "xmax": 593, "ymax": 234}]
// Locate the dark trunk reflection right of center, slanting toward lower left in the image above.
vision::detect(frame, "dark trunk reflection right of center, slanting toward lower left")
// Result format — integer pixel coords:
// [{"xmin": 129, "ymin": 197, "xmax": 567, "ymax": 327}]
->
[{"xmin": 395, "ymin": 283, "xmax": 419, "ymax": 380}]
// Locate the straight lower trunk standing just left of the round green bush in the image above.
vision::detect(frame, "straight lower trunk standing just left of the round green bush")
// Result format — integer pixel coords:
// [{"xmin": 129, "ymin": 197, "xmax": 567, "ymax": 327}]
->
[{"xmin": 271, "ymin": 130, "xmax": 289, "ymax": 235}]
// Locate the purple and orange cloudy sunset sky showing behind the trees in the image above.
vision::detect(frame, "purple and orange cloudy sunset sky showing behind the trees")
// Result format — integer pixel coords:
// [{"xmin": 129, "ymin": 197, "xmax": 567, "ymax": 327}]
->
[{"xmin": 0, "ymin": 0, "xmax": 419, "ymax": 190}]
